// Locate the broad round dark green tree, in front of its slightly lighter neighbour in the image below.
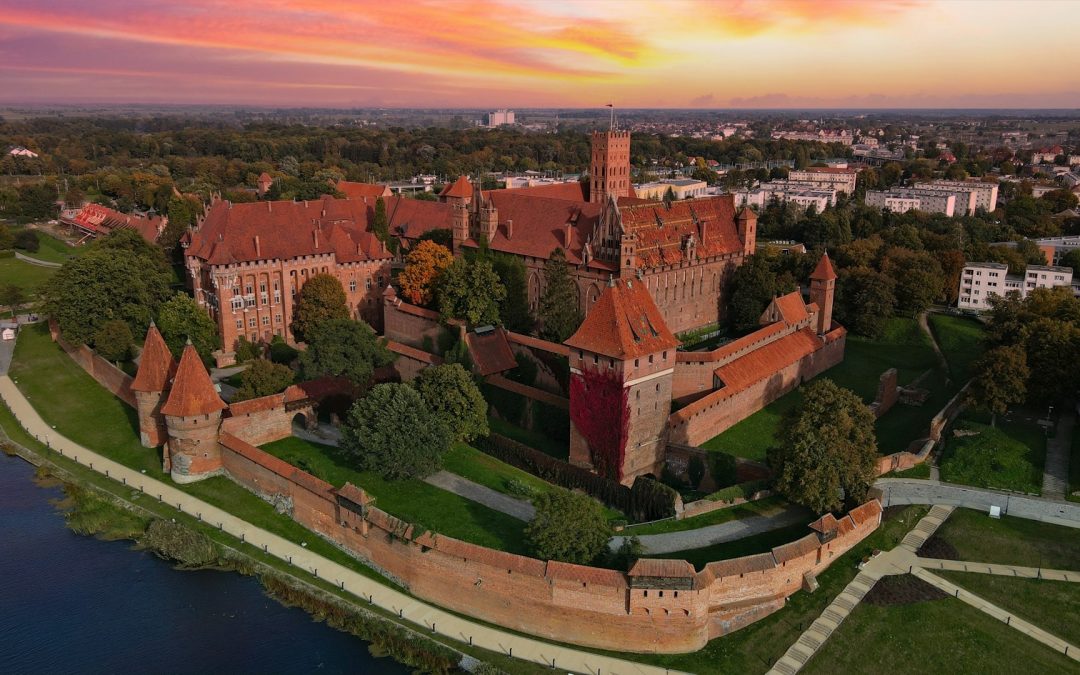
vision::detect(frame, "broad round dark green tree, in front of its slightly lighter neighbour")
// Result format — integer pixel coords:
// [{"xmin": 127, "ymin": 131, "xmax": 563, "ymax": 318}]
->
[{"xmin": 341, "ymin": 383, "xmax": 450, "ymax": 481}]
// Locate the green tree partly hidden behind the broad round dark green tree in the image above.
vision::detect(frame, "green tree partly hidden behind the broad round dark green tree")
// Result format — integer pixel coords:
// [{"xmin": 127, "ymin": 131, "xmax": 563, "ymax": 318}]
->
[{"xmin": 410, "ymin": 363, "xmax": 488, "ymax": 442}]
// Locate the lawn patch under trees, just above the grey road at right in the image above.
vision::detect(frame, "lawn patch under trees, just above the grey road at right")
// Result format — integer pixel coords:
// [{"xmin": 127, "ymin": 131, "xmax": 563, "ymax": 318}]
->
[{"xmin": 939, "ymin": 415, "xmax": 1047, "ymax": 495}]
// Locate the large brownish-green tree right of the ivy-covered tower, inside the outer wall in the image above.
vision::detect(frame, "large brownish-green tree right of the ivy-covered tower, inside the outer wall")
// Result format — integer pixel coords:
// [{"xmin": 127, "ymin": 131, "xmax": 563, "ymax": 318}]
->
[{"xmin": 769, "ymin": 379, "xmax": 878, "ymax": 513}]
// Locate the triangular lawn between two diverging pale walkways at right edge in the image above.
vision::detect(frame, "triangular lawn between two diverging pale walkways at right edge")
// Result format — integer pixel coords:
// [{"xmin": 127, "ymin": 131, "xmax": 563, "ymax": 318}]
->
[{"xmin": 934, "ymin": 561, "xmax": 1080, "ymax": 645}]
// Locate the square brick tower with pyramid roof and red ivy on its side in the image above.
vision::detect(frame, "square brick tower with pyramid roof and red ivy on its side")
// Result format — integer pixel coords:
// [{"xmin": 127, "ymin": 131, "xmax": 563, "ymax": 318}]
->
[{"xmin": 566, "ymin": 279, "xmax": 678, "ymax": 485}]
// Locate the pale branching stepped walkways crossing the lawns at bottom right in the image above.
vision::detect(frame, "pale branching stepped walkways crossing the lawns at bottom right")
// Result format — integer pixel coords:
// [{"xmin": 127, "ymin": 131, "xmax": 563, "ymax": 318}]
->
[{"xmin": 769, "ymin": 505, "xmax": 1080, "ymax": 675}]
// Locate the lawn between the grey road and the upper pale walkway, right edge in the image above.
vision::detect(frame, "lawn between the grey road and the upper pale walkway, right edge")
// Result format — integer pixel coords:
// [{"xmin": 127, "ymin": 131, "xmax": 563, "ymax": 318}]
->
[{"xmin": 934, "ymin": 509, "xmax": 1080, "ymax": 570}]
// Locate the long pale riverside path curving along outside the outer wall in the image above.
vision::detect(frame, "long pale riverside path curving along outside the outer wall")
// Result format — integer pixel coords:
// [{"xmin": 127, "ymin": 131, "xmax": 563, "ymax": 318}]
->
[{"xmin": 0, "ymin": 376, "xmax": 669, "ymax": 675}]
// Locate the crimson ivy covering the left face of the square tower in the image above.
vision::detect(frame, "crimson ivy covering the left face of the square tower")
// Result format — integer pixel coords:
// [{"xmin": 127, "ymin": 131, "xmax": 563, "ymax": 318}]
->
[{"xmin": 570, "ymin": 369, "xmax": 630, "ymax": 481}]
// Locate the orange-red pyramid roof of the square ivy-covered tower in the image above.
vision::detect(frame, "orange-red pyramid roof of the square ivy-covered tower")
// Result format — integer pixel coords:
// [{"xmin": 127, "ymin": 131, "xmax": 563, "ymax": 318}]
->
[{"xmin": 566, "ymin": 279, "xmax": 679, "ymax": 363}]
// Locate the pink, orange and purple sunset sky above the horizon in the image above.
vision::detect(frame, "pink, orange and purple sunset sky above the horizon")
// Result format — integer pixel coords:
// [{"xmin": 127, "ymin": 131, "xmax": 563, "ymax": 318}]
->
[{"xmin": 0, "ymin": 0, "xmax": 1080, "ymax": 108}]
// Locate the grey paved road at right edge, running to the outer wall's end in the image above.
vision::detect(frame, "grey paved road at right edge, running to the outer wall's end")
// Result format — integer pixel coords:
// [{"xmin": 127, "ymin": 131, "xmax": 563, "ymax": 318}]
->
[{"xmin": 874, "ymin": 478, "xmax": 1080, "ymax": 528}]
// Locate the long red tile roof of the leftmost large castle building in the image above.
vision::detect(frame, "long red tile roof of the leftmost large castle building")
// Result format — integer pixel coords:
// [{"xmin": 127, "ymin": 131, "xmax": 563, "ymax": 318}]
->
[{"xmin": 187, "ymin": 198, "xmax": 392, "ymax": 265}]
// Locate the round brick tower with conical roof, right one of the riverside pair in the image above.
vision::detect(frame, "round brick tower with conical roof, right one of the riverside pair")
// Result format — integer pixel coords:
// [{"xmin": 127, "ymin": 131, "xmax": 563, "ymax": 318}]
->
[{"xmin": 161, "ymin": 342, "xmax": 227, "ymax": 483}]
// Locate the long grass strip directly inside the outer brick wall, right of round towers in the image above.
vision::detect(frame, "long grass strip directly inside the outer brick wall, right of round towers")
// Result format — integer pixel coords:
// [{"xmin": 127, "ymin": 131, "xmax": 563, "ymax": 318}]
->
[{"xmin": 262, "ymin": 437, "xmax": 528, "ymax": 555}]
